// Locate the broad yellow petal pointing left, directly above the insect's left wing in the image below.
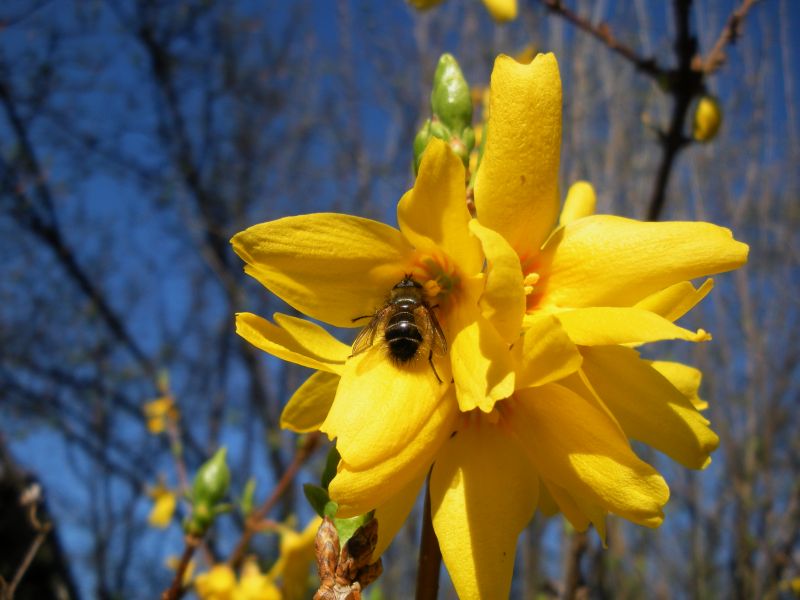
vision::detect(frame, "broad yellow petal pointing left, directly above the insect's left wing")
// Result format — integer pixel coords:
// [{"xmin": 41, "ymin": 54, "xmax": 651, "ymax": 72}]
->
[{"xmin": 231, "ymin": 213, "xmax": 413, "ymax": 327}]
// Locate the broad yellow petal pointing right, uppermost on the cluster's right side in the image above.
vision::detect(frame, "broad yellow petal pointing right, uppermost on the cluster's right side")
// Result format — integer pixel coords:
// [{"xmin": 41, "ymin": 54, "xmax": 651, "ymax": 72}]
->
[{"xmin": 535, "ymin": 215, "xmax": 748, "ymax": 307}]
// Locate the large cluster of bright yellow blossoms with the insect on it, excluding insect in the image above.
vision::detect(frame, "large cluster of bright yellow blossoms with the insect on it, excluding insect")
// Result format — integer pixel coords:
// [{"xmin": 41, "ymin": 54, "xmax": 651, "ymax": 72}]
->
[{"xmin": 233, "ymin": 55, "xmax": 747, "ymax": 598}]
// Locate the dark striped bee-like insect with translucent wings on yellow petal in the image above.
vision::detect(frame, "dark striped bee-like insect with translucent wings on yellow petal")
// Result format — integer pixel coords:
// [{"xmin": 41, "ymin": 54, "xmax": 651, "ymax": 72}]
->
[{"xmin": 352, "ymin": 275, "xmax": 447, "ymax": 383}]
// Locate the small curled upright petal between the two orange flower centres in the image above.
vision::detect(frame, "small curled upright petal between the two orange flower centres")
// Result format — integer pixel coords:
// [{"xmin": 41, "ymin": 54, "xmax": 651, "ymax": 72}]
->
[{"xmin": 469, "ymin": 219, "xmax": 525, "ymax": 344}]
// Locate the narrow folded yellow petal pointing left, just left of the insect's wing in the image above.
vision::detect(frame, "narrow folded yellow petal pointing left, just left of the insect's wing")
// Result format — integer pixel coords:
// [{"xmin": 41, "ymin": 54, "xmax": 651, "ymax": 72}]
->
[{"xmin": 236, "ymin": 313, "xmax": 350, "ymax": 373}]
